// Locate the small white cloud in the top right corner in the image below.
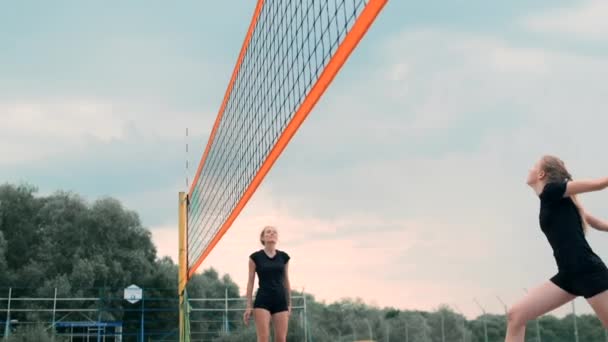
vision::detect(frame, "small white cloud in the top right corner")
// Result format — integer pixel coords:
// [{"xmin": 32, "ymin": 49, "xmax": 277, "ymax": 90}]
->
[{"xmin": 523, "ymin": 0, "xmax": 608, "ymax": 41}]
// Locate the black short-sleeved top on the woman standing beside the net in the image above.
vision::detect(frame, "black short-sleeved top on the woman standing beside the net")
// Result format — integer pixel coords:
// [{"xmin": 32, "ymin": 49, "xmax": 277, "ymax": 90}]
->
[{"xmin": 249, "ymin": 249, "xmax": 290, "ymax": 291}]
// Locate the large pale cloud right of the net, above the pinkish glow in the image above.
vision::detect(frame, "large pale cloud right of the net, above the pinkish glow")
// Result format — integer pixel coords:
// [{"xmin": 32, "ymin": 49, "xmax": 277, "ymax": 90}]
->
[{"xmin": 268, "ymin": 26, "xmax": 608, "ymax": 217}]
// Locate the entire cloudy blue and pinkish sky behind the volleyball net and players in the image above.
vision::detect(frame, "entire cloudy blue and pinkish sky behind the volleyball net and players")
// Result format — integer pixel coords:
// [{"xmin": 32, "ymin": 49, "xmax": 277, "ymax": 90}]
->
[{"xmin": 0, "ymin": 0, "xmax": 608, "ymax": 317}]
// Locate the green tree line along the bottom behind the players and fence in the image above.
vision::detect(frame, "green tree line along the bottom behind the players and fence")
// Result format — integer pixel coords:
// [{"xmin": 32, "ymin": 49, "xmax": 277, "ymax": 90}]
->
[{"xmin": 0, "ymin": 184, "xmax": 608, "ymax": 342}]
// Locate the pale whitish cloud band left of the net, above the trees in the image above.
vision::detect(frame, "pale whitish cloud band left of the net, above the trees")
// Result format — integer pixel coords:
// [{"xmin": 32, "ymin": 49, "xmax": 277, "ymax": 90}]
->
[{"xmin": 0, "ymin": 98, "xmax": 214, "ymax": 165}]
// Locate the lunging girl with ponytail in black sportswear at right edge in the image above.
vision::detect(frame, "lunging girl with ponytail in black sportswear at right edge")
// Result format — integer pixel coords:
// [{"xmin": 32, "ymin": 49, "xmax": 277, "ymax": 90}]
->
[{"xmin": 505, "ymin": 156, "xmax": 608, "ymax": 342}]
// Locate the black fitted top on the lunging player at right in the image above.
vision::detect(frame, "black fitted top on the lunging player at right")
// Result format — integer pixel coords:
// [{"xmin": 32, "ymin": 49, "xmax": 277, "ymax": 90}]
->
[{"xmin": 539, "ymin": 182, "xmax": 605, "ymax": 272}]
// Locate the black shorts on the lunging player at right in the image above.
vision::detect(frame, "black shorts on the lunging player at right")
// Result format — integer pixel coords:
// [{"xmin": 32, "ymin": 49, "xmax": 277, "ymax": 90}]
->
[{"xmin": 551, "ymin": 267, "xmax": 608, "ymax": 298}]
